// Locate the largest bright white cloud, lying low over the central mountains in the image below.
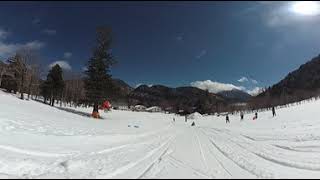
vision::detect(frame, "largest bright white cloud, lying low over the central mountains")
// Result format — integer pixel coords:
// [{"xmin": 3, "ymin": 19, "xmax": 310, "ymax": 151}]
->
[{"xmin": 191, "ymin": 80, "xmax": 245, "ymax": 93}]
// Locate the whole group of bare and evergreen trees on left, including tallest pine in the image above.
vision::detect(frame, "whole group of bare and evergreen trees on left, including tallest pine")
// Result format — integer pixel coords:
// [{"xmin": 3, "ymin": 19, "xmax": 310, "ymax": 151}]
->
[{"xmin": 0, "ymin": 27, "xmax": 118, "ymax": 117}]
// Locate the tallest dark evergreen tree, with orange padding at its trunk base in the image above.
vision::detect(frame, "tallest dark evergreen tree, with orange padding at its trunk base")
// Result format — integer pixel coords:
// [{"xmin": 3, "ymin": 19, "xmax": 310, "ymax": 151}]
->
[{"xmin": 84, "ymin": 27, "xmax": 115, "ymax": 118}]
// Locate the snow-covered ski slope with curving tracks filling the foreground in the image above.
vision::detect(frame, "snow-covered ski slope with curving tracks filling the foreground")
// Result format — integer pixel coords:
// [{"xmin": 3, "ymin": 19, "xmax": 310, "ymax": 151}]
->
[{"xmin": 0, "ymin": 91, "xmax": 320, "ymax": 178}]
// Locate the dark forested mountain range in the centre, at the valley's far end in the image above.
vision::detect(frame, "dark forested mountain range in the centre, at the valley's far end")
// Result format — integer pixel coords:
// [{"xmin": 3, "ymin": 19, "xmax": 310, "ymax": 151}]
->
[{"xmin": 128, "ymin": 85, "xmax": 227, "ymax": 113}]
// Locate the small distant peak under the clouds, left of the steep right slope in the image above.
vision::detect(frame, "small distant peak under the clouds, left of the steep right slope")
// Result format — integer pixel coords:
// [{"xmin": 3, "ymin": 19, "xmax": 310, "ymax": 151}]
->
[{"xmin": 217, "ymin": 89, "xmax": 252, "ymax": 102}]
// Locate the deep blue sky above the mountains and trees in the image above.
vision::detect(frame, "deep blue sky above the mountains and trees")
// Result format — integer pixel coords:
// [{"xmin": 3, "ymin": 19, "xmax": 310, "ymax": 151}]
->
[{"xmin": 0, "ymin": 1, "xmax": 320, "ymax": 95}]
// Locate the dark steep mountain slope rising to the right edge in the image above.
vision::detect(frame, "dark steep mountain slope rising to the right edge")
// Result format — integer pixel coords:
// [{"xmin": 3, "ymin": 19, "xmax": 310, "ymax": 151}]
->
[{"xmin": 254, "ymin": 55, "xmax": 320, "ymax": 106}]
